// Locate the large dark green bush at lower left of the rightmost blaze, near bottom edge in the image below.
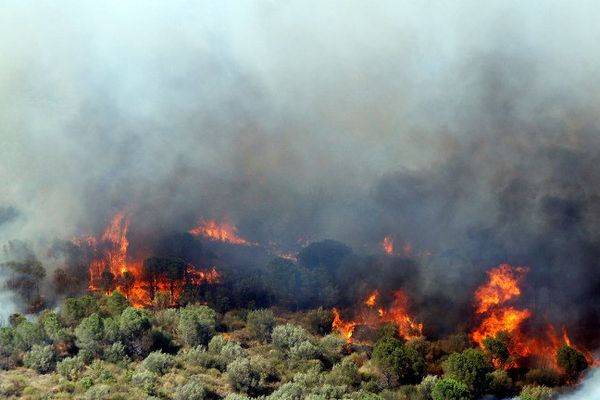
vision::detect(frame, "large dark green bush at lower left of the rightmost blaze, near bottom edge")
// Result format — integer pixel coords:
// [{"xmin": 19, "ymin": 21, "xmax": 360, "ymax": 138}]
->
[{"xmin": 442, "ymin": 349, "xmax": 493, "ymax": 395}]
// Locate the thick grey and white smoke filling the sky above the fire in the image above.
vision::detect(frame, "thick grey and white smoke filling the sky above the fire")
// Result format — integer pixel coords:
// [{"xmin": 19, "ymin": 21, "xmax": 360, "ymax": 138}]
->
[{"xmin": 0, "ymin": 0, "xmax": 600, "ymax": 338}]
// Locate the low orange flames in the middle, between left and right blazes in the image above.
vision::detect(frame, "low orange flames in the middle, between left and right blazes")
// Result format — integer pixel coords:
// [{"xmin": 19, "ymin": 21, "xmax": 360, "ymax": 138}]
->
[{"xmin": 332, "ymin": 290, "xmax": 423, "ymax": 342}]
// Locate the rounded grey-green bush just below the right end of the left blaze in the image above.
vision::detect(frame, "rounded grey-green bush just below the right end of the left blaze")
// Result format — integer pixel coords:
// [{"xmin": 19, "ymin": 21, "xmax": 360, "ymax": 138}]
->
[{"xmin": 177, "ymin": 306, "xmax": 217, "ymax": 347}]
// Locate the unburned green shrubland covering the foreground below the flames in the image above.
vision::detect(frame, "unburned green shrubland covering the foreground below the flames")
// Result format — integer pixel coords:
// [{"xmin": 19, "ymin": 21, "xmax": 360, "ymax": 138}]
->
[{"xmin": 0, "ymin": 291, "xmax": 588, "ymax": 400}]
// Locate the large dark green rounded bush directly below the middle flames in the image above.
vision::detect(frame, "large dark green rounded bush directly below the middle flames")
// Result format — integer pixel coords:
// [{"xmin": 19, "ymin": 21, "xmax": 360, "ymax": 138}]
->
[{"xmin": 372, "ymin": 337, "xmax": 425, "ymax": 387}]
